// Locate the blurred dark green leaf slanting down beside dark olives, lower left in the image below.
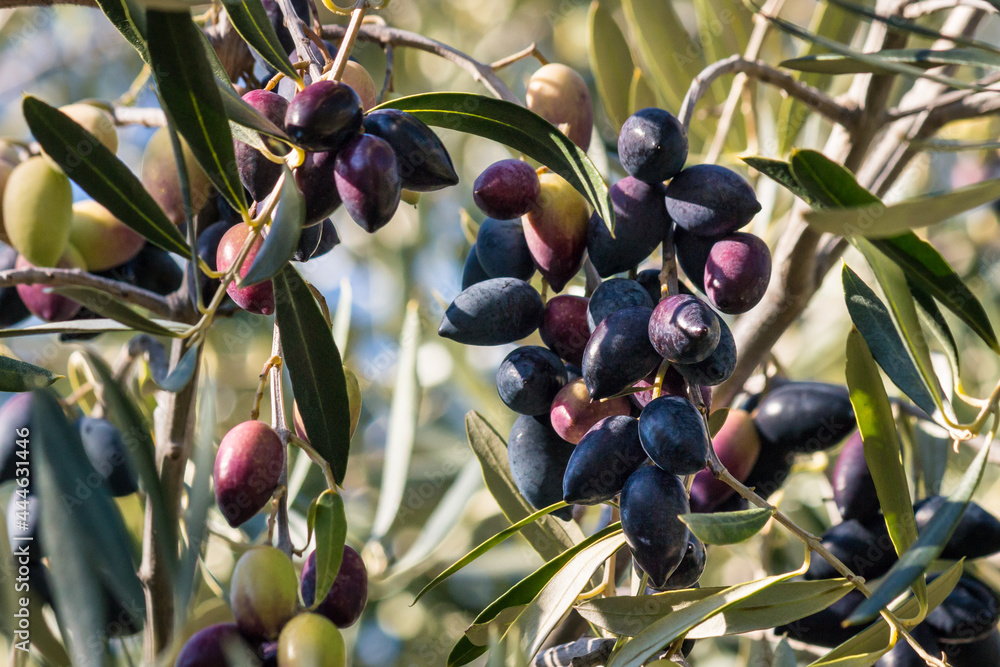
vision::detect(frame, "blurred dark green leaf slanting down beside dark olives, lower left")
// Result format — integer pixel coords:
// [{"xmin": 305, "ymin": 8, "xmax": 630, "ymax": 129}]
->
[{"xmin": 83, "ymin": 348, "xmax": 180, "ymax": 576}]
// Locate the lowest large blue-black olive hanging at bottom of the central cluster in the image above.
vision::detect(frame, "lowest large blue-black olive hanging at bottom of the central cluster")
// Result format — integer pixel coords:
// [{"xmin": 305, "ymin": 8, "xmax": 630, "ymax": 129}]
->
[{"xmin": 619, "ymin": 466, "xmax": 690, "ymax": 588}]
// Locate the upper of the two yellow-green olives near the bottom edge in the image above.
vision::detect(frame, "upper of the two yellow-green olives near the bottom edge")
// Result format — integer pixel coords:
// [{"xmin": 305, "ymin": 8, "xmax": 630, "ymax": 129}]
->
[{"xmin": 230, "ymin": 546, "xmax": 299, "ymax": 639}]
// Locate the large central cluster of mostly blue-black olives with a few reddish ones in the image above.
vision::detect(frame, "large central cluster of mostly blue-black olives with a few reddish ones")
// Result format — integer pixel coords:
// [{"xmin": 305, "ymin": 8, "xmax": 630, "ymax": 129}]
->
[{"xmin": 439, "ymin": 96, "xmax": 771, "ymax": 589}]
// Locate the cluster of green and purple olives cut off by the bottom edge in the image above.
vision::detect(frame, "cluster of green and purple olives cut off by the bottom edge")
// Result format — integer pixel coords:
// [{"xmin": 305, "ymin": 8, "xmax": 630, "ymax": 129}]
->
[{"xmin": 174, "ymin": 546, "xmax": 368, "ymax": 667}]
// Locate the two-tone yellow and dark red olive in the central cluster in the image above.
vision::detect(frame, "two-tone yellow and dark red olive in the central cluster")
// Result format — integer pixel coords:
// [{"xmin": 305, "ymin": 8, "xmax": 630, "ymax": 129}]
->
[{"xmin": 522, "ymin": 172, "xmax": 590, "ymax": 292}]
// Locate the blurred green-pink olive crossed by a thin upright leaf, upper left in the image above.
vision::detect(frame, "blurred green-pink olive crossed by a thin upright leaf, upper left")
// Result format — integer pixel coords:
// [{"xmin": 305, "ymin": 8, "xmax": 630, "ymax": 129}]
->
[{"xmin": 142, "ymin": 127, "xmax": 212, "ymax": 225}]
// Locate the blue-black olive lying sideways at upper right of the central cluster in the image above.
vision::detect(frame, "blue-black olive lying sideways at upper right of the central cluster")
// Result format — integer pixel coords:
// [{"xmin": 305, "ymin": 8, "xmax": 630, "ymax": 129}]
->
[{"xmin": 666, "ymin": 164, "xmax": 760, "ymax": 236}]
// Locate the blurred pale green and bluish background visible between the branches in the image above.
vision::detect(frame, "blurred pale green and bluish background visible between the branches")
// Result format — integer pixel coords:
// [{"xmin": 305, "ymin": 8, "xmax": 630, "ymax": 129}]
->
[{"xmin": 0, "ymin": 0, "xmax": 1000, "ymax": 667}]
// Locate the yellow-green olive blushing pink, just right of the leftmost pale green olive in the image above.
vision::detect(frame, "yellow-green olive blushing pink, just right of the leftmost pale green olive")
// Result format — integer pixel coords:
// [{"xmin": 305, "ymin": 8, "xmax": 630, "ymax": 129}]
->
[{"xmin": 69, "ymin": 200, "xmax": 146, "ymax": 271}]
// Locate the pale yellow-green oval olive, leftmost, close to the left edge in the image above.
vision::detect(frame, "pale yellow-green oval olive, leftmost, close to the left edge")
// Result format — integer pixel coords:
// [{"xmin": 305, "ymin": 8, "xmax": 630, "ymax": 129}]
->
[{"xmin": 3, "ymin": 157, "xmax": 73, "ymax": 267}]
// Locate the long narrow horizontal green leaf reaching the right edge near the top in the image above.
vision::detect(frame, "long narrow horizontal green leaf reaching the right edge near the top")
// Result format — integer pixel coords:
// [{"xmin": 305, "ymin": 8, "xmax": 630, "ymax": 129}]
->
[{"xmin": 780, "ymin": 48, "xmax": 1000, "ymax": 74}]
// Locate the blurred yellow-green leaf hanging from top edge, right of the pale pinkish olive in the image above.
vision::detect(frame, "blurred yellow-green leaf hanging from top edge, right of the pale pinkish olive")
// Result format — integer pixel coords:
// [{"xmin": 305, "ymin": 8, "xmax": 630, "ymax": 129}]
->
[{"xmin": 587, "ymin": 0, "xmax": 635, "ymax": 132}]
